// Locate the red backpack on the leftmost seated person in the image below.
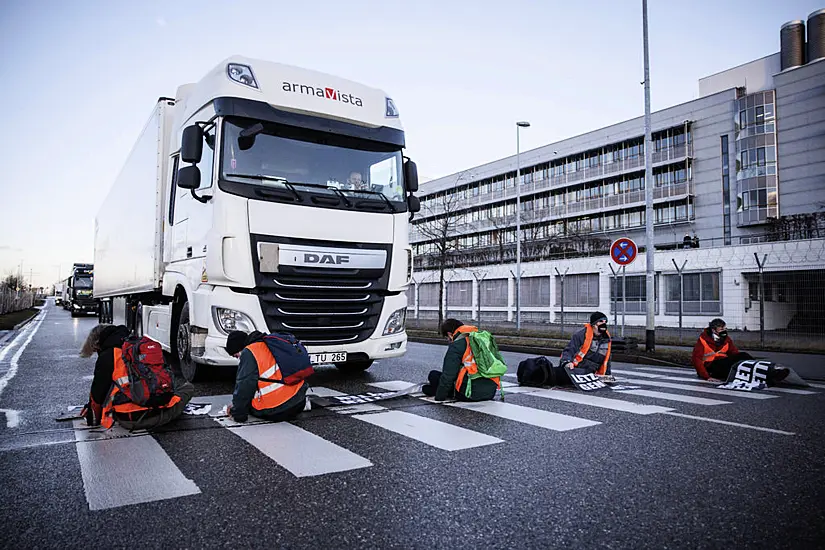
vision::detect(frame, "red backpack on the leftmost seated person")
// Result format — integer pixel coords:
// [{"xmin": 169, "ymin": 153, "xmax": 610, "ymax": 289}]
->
[{"xmin": 115, "ymin": 336, "xmax": 175, "ymax": 408}]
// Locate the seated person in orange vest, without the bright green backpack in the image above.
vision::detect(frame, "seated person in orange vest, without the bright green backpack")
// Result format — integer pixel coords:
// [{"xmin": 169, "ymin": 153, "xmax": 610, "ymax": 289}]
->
[{"xmin": 421, "ymin": 319, "xmax": 501, "ymax": 401}]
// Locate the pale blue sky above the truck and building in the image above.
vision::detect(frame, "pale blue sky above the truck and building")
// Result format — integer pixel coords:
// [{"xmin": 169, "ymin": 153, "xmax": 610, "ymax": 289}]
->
[{"xmin": 0, "ymin": 0, "xmax": 825, "ymax": 286}]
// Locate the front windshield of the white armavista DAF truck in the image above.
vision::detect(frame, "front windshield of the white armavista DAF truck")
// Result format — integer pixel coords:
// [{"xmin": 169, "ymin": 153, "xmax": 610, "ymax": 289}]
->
[{"xmin": 221, "ymin": 120, "xmax": 406, "ymax": 212}]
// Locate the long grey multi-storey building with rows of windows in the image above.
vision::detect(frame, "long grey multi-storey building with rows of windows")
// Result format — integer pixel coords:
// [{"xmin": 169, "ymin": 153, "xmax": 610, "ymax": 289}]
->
[{"xmin": 408, "ymin": 12, "xmax": 825, "ymax": 338}]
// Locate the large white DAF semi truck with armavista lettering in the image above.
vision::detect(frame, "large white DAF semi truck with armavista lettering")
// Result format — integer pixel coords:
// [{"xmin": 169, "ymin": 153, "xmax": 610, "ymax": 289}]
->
[{"xmin": 94, "ymin": 56, "xmax": 420, "ymax": 380}]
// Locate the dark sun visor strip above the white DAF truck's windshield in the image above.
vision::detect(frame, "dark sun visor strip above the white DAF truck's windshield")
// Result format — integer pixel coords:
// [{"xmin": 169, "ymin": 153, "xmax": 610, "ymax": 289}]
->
[{"xmin": 213, "ymin": 97, "xmax": 405, "ymax": 147}]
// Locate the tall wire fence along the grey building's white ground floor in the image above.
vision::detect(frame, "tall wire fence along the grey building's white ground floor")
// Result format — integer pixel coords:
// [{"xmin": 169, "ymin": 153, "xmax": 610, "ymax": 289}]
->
[{"xmin": 408, "ymin": 239, "xmax": 825, "ymax": 352}]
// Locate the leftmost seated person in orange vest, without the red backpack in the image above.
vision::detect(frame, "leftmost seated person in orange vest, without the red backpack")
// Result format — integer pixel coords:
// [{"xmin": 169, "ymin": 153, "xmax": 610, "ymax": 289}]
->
[{"xmin": 80, "ymin": 324, "xmax": 195, "ymax": 430}]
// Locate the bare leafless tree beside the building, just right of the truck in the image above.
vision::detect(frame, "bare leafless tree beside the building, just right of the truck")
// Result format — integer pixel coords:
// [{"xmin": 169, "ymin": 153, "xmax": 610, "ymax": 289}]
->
[{"xmin": 416, "ymin": 190, "xmax": 461, "ymax": 327}]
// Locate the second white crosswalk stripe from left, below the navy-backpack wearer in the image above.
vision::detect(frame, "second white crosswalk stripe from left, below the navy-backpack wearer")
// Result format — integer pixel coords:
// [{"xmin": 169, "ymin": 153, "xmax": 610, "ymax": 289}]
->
[{"xmin": 230, "ymin": 422, "xmax": 372, "ymax": 477}]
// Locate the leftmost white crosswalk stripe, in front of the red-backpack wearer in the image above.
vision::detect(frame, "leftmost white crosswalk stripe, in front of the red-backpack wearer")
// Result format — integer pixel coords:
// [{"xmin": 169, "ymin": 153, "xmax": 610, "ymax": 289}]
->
[{"xmin": 74, "ymin": 420, "xmax": 201, "ymax": 510}]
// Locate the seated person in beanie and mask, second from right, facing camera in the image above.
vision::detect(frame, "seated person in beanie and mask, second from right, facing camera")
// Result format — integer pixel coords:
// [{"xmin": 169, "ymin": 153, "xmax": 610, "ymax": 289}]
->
[{"xmin": 559, "ymin": 311, "xmax": 613, "ymax": 382}]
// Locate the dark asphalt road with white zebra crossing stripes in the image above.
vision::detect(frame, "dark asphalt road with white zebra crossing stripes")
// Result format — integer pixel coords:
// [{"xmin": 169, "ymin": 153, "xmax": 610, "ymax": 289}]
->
[{"xmin": 0, "ymin": 302, "xmax": 825, "ymax": 549}]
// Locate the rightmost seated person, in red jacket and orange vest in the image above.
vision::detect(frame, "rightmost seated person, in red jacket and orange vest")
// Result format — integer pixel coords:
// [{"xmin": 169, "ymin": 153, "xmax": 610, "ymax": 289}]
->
[{"xmin": 691, "ymin": 318, "xmax": 790, "ymax": 385}]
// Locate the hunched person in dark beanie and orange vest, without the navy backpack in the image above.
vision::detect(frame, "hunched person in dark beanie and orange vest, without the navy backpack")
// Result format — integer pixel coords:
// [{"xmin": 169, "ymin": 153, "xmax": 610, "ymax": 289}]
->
[{"xmin": 220, "ymin": 330, "xmax": 308, "ymax": 422}]
